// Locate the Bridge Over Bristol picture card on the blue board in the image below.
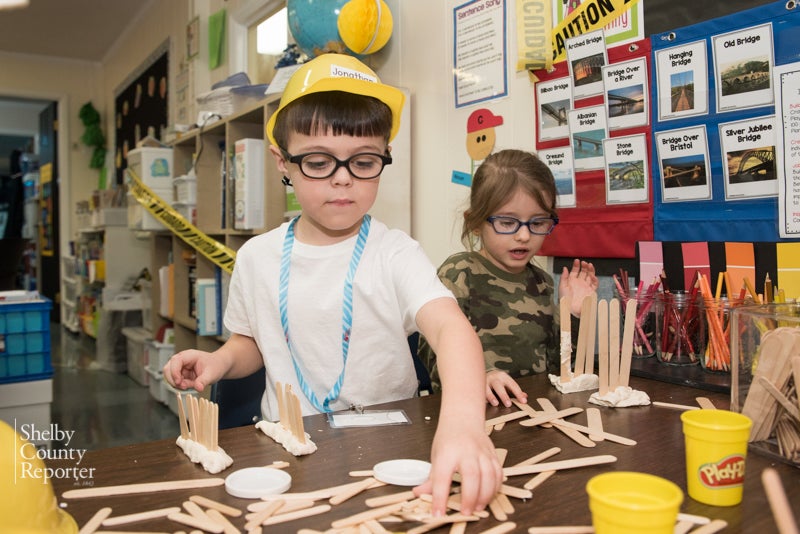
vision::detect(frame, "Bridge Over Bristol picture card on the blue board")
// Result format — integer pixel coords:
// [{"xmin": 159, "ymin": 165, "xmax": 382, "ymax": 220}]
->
[{"xmin": 654, "ymin": 125, "xmax": 711, "ymax": 202}]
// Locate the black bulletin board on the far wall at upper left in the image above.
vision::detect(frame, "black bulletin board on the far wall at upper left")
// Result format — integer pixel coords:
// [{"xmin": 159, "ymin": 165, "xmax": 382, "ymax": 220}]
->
[{"xmin": 114, "ymin": 41, "xmax": 169, "ymax": 184}]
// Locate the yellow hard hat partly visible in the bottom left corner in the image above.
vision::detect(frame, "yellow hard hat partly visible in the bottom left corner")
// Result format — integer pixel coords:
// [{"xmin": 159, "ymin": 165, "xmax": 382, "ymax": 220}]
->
[{"xmin": 0, "ymin": 421, "xmax": 78, "ymax": 534}]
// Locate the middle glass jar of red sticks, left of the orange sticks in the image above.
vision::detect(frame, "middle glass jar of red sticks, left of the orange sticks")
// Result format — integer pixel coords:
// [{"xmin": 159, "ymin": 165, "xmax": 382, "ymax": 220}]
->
[{"xmin": 656, "ymin": 291, "xmax": 706, "ymax": 365}]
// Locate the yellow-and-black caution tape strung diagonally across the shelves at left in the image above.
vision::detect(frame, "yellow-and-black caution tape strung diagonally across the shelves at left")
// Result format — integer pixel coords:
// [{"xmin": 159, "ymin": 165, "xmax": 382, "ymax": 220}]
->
[{"xmin": 127, "ymin": 168, "xmax": 236, "ymax": 273}]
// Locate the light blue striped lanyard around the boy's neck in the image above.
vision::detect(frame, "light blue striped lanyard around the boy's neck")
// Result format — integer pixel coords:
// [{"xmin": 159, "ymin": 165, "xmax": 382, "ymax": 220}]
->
[{"xmin": 278, "ymin": 215, "xmax": 371, "ymax": 412}]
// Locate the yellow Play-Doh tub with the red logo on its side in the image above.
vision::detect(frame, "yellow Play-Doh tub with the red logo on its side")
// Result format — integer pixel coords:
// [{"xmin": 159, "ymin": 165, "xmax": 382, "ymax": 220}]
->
[{"xmin": 681, "ymin": 410, "xmax": 753, "ymax": 506}]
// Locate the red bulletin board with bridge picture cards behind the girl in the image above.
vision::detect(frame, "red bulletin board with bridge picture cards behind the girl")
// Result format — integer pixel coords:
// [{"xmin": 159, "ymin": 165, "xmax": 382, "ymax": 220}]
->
[{"xmin": 534, "ymin": 37, "xmax": 653, "ymax": 258}]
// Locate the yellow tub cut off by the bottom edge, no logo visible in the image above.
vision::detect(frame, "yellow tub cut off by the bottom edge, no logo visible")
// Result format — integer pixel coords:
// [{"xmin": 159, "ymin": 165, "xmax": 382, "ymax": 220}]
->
[{"xmin": 586, "ymin": 471, "xmax": 683, "ymax": 534}]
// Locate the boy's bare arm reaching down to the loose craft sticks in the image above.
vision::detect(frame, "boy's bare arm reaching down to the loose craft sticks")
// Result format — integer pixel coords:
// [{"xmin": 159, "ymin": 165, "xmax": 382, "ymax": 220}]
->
[{"xmin": 415, "ymin": 298, "xmax": 502, "ymax": 516}]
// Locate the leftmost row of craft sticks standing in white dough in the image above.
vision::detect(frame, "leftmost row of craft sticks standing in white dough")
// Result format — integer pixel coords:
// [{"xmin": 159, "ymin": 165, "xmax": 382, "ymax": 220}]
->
[{"xmin": 175, "ymin": 392, "xmax": 233, "ymax": 474}]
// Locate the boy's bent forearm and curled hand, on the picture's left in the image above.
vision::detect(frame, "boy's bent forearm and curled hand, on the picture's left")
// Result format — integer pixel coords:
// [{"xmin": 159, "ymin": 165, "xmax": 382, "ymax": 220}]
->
[{"xmin": 163, "ymin": 334, "xmax": 264, "ymax": 391}]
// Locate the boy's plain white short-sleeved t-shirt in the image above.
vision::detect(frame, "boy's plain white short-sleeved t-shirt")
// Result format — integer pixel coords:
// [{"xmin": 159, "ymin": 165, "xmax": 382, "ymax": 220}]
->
[{"xmin": 224, "ymin": 218, "xmax": 453, "ymax": 421}]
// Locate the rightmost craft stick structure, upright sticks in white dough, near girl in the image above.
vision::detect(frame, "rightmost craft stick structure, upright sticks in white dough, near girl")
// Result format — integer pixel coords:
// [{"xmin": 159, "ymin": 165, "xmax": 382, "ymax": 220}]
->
[{"xmin": 589, "ymin": 299, "xmax": 650, "ymax": 407}]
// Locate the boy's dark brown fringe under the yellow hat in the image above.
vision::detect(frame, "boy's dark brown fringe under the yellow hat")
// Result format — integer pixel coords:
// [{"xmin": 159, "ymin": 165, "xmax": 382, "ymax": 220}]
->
[{"xmin": 273, "ymin": 91, "xmax": 392, "ymax": 149}]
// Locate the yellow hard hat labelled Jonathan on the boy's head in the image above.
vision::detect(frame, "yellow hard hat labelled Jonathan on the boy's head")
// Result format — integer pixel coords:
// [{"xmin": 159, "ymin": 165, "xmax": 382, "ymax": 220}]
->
[{"xmin": 267, "ymin": 53, "xmax": 405, "ymax": 146}]
